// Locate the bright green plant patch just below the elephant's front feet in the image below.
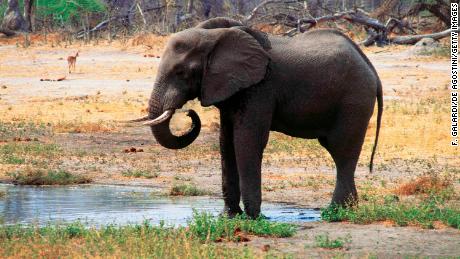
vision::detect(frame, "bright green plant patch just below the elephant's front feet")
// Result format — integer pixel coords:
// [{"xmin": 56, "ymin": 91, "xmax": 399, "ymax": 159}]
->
[{"xmin": 189, "ymin": 211, "xmax": 296, "ymax": 241}]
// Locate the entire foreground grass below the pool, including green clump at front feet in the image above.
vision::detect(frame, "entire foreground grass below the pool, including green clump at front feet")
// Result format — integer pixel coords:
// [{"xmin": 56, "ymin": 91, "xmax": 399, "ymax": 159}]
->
[{"xmin": 0, "ymin": 212, "xmax": 295, "ymax": 258}]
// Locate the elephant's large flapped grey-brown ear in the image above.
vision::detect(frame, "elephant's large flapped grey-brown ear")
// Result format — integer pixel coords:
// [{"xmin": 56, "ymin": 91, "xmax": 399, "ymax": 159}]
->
[{"xmin": 201, "ymin": 28, "xmax": 269, "ymax": 106}]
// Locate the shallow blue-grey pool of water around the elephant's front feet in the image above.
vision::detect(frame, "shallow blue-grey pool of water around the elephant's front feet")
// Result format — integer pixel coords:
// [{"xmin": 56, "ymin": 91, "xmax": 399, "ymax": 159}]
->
[{"xmin": 0, "ymin": 184, "xmax": 320, "ymax": 226}]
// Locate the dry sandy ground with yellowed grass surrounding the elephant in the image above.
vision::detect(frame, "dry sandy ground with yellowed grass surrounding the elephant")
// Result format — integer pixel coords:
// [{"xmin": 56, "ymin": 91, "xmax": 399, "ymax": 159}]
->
[{"xmin": 0, "ymin": 35, "xmax": 460, "ymax": 257}]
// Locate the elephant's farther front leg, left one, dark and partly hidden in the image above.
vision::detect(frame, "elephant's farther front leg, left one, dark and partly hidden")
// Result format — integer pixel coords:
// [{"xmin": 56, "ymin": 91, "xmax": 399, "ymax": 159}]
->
[{"xmin": 220, "ymin": 113, "xmax": 243, "ymax": 217}]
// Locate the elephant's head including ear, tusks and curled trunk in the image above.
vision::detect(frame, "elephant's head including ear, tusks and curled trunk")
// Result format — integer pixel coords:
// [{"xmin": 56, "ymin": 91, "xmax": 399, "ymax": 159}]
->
[{"xmin": 130, "ymin": 18, "xmax": 270, "ymax": 149}]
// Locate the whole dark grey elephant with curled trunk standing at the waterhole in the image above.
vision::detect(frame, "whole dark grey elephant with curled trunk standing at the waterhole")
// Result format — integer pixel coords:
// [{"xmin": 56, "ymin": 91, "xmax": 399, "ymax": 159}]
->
[{"xmin": 127, "ymin": 17, "xmax": 383, "ymax": 218}]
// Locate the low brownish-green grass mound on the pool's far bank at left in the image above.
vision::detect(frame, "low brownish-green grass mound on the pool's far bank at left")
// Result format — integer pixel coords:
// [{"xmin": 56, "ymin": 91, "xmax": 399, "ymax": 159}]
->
[{"xmin": 10, "ymin": 168, "xmax": 91, "ymax": 185}]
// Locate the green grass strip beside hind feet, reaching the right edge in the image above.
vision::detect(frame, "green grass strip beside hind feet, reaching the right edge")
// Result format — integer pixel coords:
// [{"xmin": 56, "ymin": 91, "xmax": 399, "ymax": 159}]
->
[{"xmin": 321, "ymin": 195, "xmax": 460, "ymax": 229}]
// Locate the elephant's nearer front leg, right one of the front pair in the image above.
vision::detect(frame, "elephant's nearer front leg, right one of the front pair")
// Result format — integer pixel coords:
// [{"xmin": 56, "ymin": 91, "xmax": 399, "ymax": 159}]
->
[{"xmin": 234, "ymin": 122, "xmax": 270, "ymax": 218}]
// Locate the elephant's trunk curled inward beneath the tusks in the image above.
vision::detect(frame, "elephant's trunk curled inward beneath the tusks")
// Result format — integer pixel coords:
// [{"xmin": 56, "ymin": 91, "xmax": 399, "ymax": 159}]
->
[{"xmin": 144, "ymin": 81, "xmax": 201, "ymax": 149}]
